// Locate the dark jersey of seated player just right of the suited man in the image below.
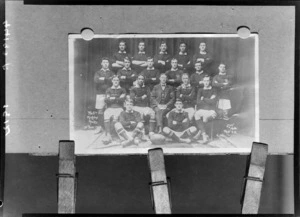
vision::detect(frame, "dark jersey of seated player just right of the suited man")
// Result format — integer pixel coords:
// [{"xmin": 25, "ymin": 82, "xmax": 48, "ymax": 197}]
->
[{"xmin": 176, "ymin": 84, "xmax": 196, "ymax": 108}]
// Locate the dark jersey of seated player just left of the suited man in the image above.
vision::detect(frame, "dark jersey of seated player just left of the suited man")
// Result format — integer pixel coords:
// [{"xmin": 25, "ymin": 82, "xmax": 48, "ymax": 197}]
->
[{"xmin": 130, "ymin": 85, "xmax": 151, "ymax": 107}]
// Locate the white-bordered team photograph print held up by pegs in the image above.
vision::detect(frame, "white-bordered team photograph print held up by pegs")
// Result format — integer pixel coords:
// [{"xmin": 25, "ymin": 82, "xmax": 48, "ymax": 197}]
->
[{"xmin": 69, "ymin": 34, "xmax": 259, "ymax": 155}]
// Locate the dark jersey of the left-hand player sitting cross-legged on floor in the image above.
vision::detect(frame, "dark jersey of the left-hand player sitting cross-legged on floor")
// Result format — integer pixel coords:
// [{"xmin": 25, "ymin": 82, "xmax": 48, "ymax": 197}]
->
[{"xmin": 120, "ymin": 110, "xmax": 142, "ymax": 131}]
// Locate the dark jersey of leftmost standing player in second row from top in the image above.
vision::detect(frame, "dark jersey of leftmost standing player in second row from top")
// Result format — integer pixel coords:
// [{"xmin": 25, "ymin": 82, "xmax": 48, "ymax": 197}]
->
[{"xmin": 94, "ymin": 69, "xmax": 114, "ymax": 94}]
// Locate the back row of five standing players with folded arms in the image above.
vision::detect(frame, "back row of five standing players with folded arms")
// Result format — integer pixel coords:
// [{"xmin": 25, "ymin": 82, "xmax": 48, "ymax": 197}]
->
[{"xmin": 111, "ymin": 41, "xmax": 213, "ymax": 76}]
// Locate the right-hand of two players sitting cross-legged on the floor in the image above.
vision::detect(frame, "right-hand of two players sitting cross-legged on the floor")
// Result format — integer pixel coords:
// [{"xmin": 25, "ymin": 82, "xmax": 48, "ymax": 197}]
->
[{"xmin": 163, "ymin": 98, "xmax": 197, "ymax": 143}]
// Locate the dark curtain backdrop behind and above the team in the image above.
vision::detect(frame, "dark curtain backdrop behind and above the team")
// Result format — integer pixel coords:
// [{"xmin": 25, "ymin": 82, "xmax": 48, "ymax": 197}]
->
[{"xmin": 74, "ymin": 37, "xmax": 255, "ymax": 127}]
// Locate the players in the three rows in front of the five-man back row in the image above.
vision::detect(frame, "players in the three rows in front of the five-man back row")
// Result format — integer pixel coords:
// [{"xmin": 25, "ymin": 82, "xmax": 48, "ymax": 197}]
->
[{"xmin": 94, "ymin": 58, "xmax": 232, "ymax": 146}]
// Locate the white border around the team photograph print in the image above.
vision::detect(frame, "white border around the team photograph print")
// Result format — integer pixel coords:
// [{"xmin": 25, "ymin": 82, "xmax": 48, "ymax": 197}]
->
[{"xmin": 68, "ymin": 34, "xmax": 260, "ymax": 155}]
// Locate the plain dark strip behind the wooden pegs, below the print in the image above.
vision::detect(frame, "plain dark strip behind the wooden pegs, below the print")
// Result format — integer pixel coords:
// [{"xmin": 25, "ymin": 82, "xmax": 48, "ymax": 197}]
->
[{"xmin": 4, "ymin": 154, "xmax": 293, "ymax": 217}]
